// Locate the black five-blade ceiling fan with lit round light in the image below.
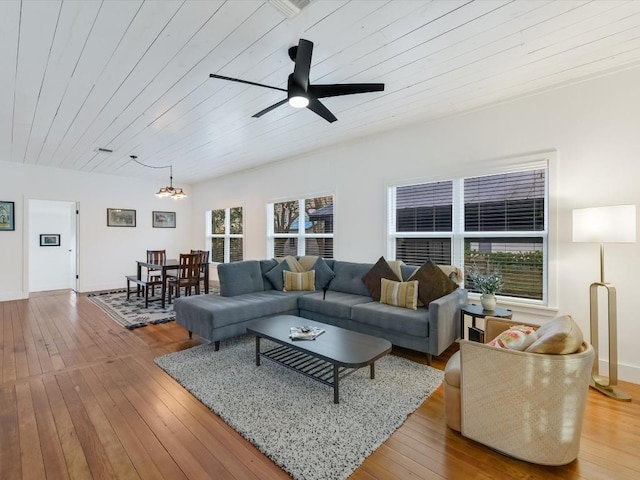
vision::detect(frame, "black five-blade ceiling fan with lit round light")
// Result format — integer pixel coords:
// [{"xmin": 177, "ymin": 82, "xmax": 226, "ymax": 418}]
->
[{"xmin": 209, "ymin": 38, "xmax": 384, "ymax": 122}]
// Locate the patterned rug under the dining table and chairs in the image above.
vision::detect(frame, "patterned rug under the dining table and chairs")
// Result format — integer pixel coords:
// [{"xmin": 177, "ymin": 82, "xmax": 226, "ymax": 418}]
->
[{"xmin": 87, "ymin": 290, "xmax": 175, "ymax": 330}]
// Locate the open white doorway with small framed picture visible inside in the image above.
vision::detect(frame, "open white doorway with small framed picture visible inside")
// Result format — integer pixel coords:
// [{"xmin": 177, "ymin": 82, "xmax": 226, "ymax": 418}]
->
[{"xmin": 27, "ymin": 199, "xmax": 78, "ymax": 292}]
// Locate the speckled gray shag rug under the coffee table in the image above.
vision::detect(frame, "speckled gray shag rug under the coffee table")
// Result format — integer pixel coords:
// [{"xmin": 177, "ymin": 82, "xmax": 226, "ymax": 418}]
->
[{"xmin": 155, "ymin": 336, "xmax": 443, "ymax": 480}]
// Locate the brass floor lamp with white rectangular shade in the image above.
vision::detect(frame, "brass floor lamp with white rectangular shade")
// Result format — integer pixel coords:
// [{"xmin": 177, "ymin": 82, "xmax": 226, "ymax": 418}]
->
[{"xmin": 573, "ymin": 205, "xmax": 636, "ymax": 401}]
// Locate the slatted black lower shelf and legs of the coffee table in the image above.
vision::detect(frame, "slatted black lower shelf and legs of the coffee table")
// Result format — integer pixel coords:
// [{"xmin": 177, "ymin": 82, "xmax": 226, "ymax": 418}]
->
[{"xmin": 256, "ymin": 337, "xmax": 375, "ymax": 403}]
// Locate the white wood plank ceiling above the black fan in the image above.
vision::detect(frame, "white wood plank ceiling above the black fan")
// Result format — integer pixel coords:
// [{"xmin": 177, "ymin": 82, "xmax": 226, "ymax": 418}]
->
[{"xmin": 0, "ymin": 0, "xmax": 640, "ymax": 184}]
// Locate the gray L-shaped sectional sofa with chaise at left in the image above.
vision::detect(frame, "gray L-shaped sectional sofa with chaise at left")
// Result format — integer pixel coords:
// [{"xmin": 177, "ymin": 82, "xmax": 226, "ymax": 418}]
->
[{"xmin": 174, "ymin": 259, "xmax": 467, "ymax": 362}]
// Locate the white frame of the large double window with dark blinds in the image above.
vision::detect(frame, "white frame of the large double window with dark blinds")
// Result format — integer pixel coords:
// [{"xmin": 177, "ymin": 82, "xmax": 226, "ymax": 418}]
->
[{"xmin": 387, "ymin": 151, "xmax": 557, "ymax": 306}]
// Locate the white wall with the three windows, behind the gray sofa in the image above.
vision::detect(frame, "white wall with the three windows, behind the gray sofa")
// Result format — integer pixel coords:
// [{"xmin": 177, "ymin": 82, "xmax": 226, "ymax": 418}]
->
[{"xmin": 193, "ymin": 68, "xmax": 640, "ymax": 382}]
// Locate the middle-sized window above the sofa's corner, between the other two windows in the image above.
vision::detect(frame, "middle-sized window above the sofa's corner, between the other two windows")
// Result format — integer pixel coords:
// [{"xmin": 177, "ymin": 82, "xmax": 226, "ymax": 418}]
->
[{"xmin": 267, "ymin": 195, "xmax": 333, "ymax": 258}]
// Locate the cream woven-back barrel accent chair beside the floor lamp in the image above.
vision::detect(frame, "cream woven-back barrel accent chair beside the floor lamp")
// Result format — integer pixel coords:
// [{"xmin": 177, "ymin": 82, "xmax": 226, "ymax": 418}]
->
[{"xmin": 444, "ymin": 317, "xmax": 594, "ymax": 465}]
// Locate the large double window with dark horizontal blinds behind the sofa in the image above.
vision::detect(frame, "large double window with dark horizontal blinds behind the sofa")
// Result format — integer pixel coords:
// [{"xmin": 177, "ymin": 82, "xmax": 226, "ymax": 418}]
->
[{"xmin": 389, "ymin": 165, "xmax": 548, "ymax": 303}]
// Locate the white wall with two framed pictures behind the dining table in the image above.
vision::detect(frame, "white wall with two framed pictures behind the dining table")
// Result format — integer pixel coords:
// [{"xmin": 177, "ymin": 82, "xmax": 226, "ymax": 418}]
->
[{"xmin": 0, "ymin": 161, "xmax": 195, "ymax": 301}]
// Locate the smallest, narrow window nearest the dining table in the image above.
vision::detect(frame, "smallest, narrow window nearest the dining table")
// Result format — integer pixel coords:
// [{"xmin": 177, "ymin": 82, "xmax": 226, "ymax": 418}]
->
[{"xmin": 208, "ymin": 207, "xmax": 243, "ymax": 263}]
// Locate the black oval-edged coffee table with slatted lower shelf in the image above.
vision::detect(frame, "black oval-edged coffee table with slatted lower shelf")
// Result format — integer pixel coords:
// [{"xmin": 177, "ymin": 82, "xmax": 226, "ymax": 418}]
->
[{"xmin": 247, "ymin": 315, "xmax": 391, "ymax": 403}]
